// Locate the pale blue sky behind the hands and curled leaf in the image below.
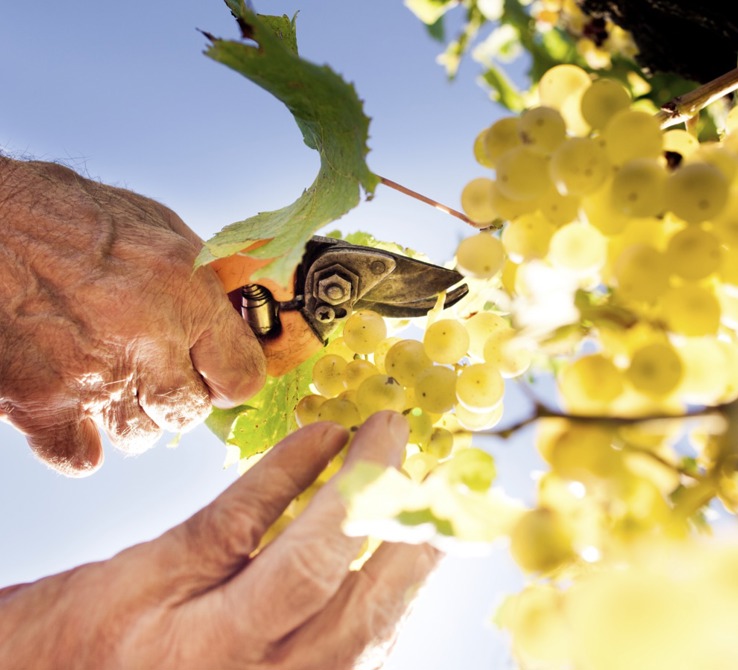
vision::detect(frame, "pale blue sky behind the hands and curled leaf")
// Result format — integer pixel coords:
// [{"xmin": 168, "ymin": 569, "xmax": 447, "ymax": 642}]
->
[{"xmin": 0, "ymin": 0, "xmax": 528, "ymax": 670}]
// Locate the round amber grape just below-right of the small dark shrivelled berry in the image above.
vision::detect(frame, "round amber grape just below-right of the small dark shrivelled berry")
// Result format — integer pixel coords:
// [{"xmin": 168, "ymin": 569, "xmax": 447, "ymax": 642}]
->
[{"xmin": 666, "ymin": 163, "xmax": 728, "ymax": 223}]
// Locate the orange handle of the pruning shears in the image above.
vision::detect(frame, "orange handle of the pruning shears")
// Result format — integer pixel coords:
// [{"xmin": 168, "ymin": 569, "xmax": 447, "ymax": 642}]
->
[{"xmin": 211, "ymin": 245, "xmax": 323, "ymax": 377}]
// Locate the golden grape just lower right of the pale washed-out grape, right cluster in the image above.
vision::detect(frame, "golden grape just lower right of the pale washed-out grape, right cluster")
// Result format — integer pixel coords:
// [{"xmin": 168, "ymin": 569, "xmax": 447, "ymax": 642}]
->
[{"xmin": 614, "ymin": 244, "xmax": 669, "ymax": 302}]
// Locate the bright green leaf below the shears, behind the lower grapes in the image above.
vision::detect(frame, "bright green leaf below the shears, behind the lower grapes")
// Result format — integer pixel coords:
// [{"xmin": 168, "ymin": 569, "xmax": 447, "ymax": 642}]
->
[{"xmin": 205, "ymin": 350, "xmax": 325, "ymax": 459}]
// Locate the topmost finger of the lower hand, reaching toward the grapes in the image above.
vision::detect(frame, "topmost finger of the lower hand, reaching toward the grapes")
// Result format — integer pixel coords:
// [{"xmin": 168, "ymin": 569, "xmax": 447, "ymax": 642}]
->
[{"xmin": 136, "ymin": 422, "xmax": 348, "ymax": 610}]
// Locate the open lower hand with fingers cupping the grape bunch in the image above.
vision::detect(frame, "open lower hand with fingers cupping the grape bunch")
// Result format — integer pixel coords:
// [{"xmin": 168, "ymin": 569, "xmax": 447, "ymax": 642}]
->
[{"xmin": 0, "ymin": 412, "xmax": 438, "ymax": 670}]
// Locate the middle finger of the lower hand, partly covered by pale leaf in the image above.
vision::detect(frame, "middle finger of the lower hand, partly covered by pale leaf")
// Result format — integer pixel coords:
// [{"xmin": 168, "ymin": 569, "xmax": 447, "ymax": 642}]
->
[{"xmin": 229, "ymin": 412, "xmax": 408, "ymax": 641}]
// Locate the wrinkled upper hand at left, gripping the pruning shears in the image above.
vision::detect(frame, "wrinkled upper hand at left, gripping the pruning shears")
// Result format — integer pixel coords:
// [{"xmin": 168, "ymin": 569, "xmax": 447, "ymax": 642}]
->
[{"xmin": 0, "ymin": 157, "xmax": 265, "ymax": 474}]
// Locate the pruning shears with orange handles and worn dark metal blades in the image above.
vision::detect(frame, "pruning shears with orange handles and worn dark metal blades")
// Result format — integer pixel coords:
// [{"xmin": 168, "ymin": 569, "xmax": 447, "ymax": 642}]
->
[{"xmin": 212, "ymin": 236, "xmax": 469, "ymax": 376}]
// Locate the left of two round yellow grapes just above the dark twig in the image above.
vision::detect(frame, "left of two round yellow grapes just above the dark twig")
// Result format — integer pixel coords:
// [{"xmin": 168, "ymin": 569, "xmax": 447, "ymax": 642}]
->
[{"xmin": 557, "ymin": 354, "xmax": 625, "ymax": 413}]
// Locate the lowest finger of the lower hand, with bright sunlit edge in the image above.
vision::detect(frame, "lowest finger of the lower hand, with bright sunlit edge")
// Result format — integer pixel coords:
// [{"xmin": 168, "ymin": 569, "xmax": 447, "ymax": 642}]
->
[{"xmin": 278, "ymin": 544, "xmax": 442, "ymax": 669}]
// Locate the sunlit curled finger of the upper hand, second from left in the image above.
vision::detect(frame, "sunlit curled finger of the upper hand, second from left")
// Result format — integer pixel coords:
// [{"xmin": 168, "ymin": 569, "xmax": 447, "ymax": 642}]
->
[{"xmin": 100, "ymin": 389, "xmax": 162, "ymax": 454}]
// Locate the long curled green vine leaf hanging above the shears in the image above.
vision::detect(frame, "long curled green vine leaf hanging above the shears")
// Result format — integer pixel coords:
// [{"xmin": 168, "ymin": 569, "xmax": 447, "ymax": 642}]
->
[{"xmin": 197, "ymin": 0, "xmax": 379, "ymax": 286}]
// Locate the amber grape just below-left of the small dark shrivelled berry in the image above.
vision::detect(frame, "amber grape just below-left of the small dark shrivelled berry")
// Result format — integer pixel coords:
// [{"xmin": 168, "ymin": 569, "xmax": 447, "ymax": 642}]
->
[{"xmin": 611, "ymin": 158, "xmax": 670, "ymax": 218}]
